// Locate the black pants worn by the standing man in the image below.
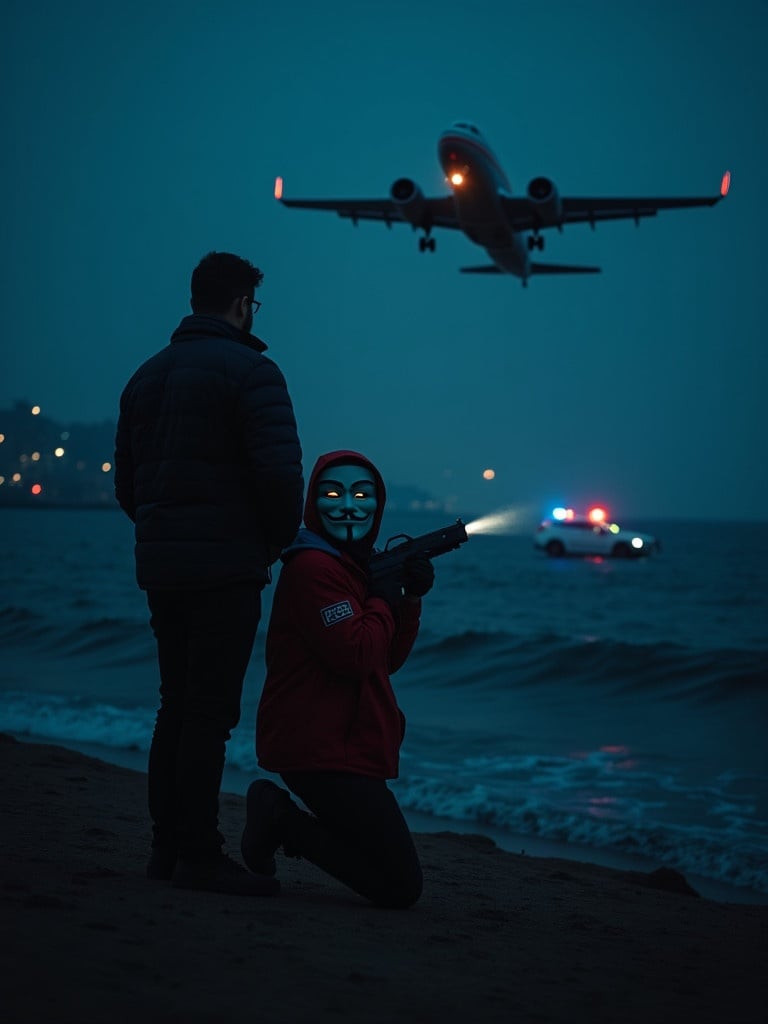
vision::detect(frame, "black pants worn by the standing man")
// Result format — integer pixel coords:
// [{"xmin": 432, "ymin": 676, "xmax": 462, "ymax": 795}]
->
[{"xmin": 146, "ymin": 583, "xmax": 261, "ymax": 860}]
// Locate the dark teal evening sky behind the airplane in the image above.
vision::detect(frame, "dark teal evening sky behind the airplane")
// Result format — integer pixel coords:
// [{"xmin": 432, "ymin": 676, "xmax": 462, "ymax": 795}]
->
[{"xmin": 0, "ymin": 0, "xmax": 768, "ymax": 516}]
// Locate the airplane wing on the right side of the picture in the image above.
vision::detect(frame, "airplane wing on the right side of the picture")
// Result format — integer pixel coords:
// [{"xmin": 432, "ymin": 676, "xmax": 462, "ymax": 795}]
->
[{"xmin": 502, "ymin": 195, "xmax": 723, "ymax": 231}]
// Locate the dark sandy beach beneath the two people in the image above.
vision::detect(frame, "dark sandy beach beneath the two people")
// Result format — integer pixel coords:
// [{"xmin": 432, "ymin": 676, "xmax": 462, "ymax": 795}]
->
[{"xmin": 0, "ymin": 736, "xmax": 768, "ymax": 1024}]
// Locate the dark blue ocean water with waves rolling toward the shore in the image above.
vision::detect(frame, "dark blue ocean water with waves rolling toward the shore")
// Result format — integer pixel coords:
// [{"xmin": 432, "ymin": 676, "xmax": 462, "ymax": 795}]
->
[{"xmin": 0, "ymin": 509, "xmax": 768, "ymax": 902}]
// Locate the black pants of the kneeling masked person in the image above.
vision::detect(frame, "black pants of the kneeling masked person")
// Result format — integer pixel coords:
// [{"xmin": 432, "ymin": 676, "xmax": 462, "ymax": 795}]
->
[{"xmin": 283, "ymin": 772, "xmax": 422, "ymax": 907}]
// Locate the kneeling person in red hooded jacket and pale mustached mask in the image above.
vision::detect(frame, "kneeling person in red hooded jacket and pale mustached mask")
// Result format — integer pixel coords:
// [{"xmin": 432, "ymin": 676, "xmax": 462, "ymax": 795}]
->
[{"xmin": 246, "ymin": 452, "xmax": 434, "ymax": 907}]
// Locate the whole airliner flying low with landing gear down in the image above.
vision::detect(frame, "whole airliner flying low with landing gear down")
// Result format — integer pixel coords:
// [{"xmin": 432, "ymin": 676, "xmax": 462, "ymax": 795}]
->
[{"xmin": 274, "ymin": 121, "xmax": 730, "ymax": 286}]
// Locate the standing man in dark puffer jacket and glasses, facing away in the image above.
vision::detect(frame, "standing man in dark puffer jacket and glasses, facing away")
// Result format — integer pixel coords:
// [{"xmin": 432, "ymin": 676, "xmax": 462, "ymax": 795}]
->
[{"xmin": 115, "ymin": 252, "xmax": 303, "ymax": 895}]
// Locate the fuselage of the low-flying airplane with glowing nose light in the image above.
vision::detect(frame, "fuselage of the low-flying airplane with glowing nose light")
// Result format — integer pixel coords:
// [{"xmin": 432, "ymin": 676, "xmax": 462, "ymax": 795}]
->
[{"xmin": 437, "ymin": 124, "xmax": 529, "ymax": 279}]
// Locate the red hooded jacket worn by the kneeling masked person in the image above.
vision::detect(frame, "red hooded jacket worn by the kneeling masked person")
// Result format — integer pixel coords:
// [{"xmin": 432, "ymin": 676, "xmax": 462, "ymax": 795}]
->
[{"xmin": 256, "ymin": 452, "xmax": 421, "ymax": 778}]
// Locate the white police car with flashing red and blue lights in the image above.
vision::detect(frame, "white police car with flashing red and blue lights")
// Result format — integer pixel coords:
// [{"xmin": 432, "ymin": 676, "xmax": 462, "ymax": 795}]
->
[{"xmin": 534, "ymin": 508, "xmax": 660, "ymax": 558}]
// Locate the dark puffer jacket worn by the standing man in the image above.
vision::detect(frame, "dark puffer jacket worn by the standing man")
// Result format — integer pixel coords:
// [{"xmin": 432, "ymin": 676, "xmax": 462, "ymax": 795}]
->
[{"xmin": 115, "ymin": 315, "xmax": 303, "ymax": 590}]
